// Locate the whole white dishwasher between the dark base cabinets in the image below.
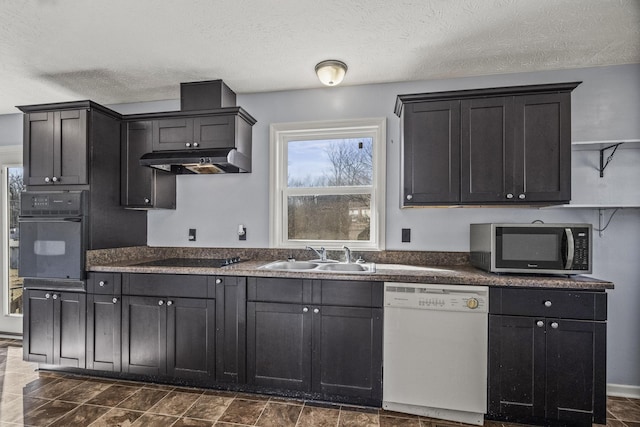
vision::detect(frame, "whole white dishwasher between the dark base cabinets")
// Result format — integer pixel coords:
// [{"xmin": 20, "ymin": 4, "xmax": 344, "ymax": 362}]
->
[{"xmin": 382, "ymin": 282, "xmax": 489, "ymax": 425}]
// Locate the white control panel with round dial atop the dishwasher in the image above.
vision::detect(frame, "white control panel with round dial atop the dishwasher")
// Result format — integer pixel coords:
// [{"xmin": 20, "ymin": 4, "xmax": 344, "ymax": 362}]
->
[{"xmin": 384, "ymin": 282, "xmax": 489, "ymax": 313}]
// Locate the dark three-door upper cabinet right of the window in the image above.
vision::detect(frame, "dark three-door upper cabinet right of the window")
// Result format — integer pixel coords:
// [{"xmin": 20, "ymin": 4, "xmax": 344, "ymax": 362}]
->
[{"xmin": 395, "ymin": 82, "xmax": 579, "ymax": 207}]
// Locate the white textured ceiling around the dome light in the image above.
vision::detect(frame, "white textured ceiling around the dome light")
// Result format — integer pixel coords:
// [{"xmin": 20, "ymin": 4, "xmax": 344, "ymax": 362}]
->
[{"xmin": 0, "ymin": 0, "xmax": 640, "ymax": 114}]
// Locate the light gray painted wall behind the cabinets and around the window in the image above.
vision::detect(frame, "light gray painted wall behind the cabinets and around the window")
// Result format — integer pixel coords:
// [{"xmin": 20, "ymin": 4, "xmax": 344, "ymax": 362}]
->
[{"xmin": 0, "ymin": 64, "xmax": 640, "ymax": 387}]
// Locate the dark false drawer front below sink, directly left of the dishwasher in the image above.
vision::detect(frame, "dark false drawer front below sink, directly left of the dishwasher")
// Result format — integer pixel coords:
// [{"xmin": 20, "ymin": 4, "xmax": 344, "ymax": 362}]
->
[{"xmin": 321, "ymin": 280, "xmax": 383, "ymax": 307}]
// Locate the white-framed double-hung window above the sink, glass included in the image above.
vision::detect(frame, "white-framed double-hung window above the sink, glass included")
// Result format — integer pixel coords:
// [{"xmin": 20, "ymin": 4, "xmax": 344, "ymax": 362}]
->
[{"xmin": 270, "ymin": 119, "xmax": 386, "ymax": 250}]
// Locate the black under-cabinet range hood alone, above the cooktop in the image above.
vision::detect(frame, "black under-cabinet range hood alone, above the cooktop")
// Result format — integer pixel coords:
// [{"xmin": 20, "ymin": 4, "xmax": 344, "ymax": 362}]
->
[{"xmin": 140, "ymin": 148, "xmax": 251, "ymax": 174}]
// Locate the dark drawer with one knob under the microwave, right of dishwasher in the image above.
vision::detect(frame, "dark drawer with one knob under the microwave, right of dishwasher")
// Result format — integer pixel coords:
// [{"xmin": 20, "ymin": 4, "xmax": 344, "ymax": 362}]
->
[{"xmin": 489, "ymin": 288, "xmax": 607, "ymax": 320}]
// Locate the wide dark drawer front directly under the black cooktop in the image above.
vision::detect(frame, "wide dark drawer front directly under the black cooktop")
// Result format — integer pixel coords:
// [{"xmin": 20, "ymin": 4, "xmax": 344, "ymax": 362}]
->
[{"xmin": 122, "ymin": 274, "xmax": 208, "ymax": 298}]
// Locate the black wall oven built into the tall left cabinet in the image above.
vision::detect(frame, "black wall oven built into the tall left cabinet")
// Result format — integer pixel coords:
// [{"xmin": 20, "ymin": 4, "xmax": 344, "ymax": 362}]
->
[{"xmin": 18, "ymin": 191, "xmax": 88, "ymax": 287}]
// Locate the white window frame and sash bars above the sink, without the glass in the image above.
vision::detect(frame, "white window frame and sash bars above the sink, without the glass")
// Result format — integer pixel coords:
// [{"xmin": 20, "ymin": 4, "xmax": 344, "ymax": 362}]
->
[{"xmin": 269, "ymin": 118, "xmax": 387, "ymax": 251}]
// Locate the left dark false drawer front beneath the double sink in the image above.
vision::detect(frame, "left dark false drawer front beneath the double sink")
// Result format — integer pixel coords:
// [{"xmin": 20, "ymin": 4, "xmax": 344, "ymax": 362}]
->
[{"xmin": 247, "ymin": 277, "xmax": 311, "ymax": 303}]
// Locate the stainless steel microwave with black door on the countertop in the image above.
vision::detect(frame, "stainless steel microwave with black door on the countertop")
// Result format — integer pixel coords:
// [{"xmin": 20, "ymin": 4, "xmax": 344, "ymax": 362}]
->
[{"xmin": 470, "ymin": 223, "xmax": 593, "ymax": 274}]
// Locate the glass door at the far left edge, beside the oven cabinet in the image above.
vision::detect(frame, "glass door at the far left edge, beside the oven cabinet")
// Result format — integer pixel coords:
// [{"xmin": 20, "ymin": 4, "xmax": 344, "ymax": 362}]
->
[{"xmin": 0, "ymin": 160, "xmax": 25, "ymax": 334}]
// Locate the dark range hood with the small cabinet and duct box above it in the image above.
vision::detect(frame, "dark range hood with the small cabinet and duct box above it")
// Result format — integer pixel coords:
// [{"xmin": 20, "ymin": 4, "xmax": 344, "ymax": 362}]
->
[{"xmin": 136, "ymin": 80, "xmax": 256, "ymax": 174}]
